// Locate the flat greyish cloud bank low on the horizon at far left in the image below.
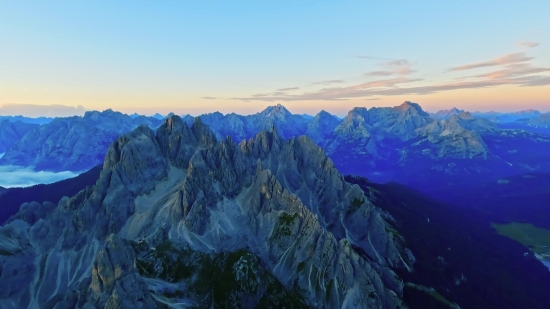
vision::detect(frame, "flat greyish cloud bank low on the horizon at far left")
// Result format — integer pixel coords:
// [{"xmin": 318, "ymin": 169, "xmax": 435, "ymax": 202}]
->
[{"xmin": 0, "ymin": 104, "xmax": 86, "ymax": 117}]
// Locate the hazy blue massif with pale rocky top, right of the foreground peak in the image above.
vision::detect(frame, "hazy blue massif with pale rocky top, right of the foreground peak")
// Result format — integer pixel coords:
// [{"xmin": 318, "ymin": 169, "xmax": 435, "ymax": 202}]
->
[{"xmin": 321, "ymin": 102, "xmax": 550, "ymax": 188}]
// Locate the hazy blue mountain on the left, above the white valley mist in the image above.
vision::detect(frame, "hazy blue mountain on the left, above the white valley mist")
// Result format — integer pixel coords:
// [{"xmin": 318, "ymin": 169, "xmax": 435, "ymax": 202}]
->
[{"xmin": 0, "ymin": 109, "xmax": 162, "ymax": 171}]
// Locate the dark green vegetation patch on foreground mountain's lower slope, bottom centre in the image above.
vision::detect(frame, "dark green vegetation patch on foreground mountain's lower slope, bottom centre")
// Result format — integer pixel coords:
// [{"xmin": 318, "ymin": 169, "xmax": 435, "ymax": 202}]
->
[{"xmin": 134, "ymin": 241, "xmax": 309, "ymax": 308}]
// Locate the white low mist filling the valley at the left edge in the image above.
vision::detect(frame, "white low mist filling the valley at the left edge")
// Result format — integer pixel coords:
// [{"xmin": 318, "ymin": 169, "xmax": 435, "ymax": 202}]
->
[{"xmin": 0, "ymin": 166, "xmax": 78, "ymax": 188}]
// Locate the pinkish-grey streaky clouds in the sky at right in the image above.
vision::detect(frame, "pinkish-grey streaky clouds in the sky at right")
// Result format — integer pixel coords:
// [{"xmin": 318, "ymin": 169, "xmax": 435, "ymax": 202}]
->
[{"xmin": 232, "ymin": 53, "xmax": 550, "ymax": 101}]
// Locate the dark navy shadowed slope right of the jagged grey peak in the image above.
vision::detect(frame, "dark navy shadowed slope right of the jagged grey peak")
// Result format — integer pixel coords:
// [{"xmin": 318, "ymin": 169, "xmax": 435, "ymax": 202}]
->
[{"xmin": 346, "ymin": 176, "xmax": 550, "ymax": 309}]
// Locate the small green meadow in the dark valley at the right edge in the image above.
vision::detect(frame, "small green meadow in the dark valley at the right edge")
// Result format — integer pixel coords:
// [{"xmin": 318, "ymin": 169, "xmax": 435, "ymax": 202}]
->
[{"xmin": 491, "ymin": 222, "xmax": 550, "ymax": 255}]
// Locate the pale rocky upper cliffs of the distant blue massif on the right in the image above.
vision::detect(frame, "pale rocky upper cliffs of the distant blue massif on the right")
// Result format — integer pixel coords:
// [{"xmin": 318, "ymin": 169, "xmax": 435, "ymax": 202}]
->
[{"xmin": 323, "ymin": 102, "xmax": 497, "ymax": 164}]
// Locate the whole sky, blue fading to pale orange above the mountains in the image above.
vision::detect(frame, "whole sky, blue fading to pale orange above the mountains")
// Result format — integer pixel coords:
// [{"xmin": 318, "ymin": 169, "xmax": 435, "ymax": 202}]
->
[{"xmin": 0, "ymin": 0, "xmax": 550, "ymax": 116}]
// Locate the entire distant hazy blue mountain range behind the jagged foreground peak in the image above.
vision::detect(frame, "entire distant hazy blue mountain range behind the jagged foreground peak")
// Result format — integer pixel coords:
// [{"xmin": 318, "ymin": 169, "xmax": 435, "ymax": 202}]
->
[{"xmin": 0, "ymin": 102, "xmax": 550, "ymax": 188}]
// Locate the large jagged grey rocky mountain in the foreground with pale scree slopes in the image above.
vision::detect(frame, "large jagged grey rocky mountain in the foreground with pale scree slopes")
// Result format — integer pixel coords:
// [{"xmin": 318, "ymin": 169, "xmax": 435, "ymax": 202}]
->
[{"xmin": 0, "ymin": 112, "xmax": 414, "ymax": 308}]
